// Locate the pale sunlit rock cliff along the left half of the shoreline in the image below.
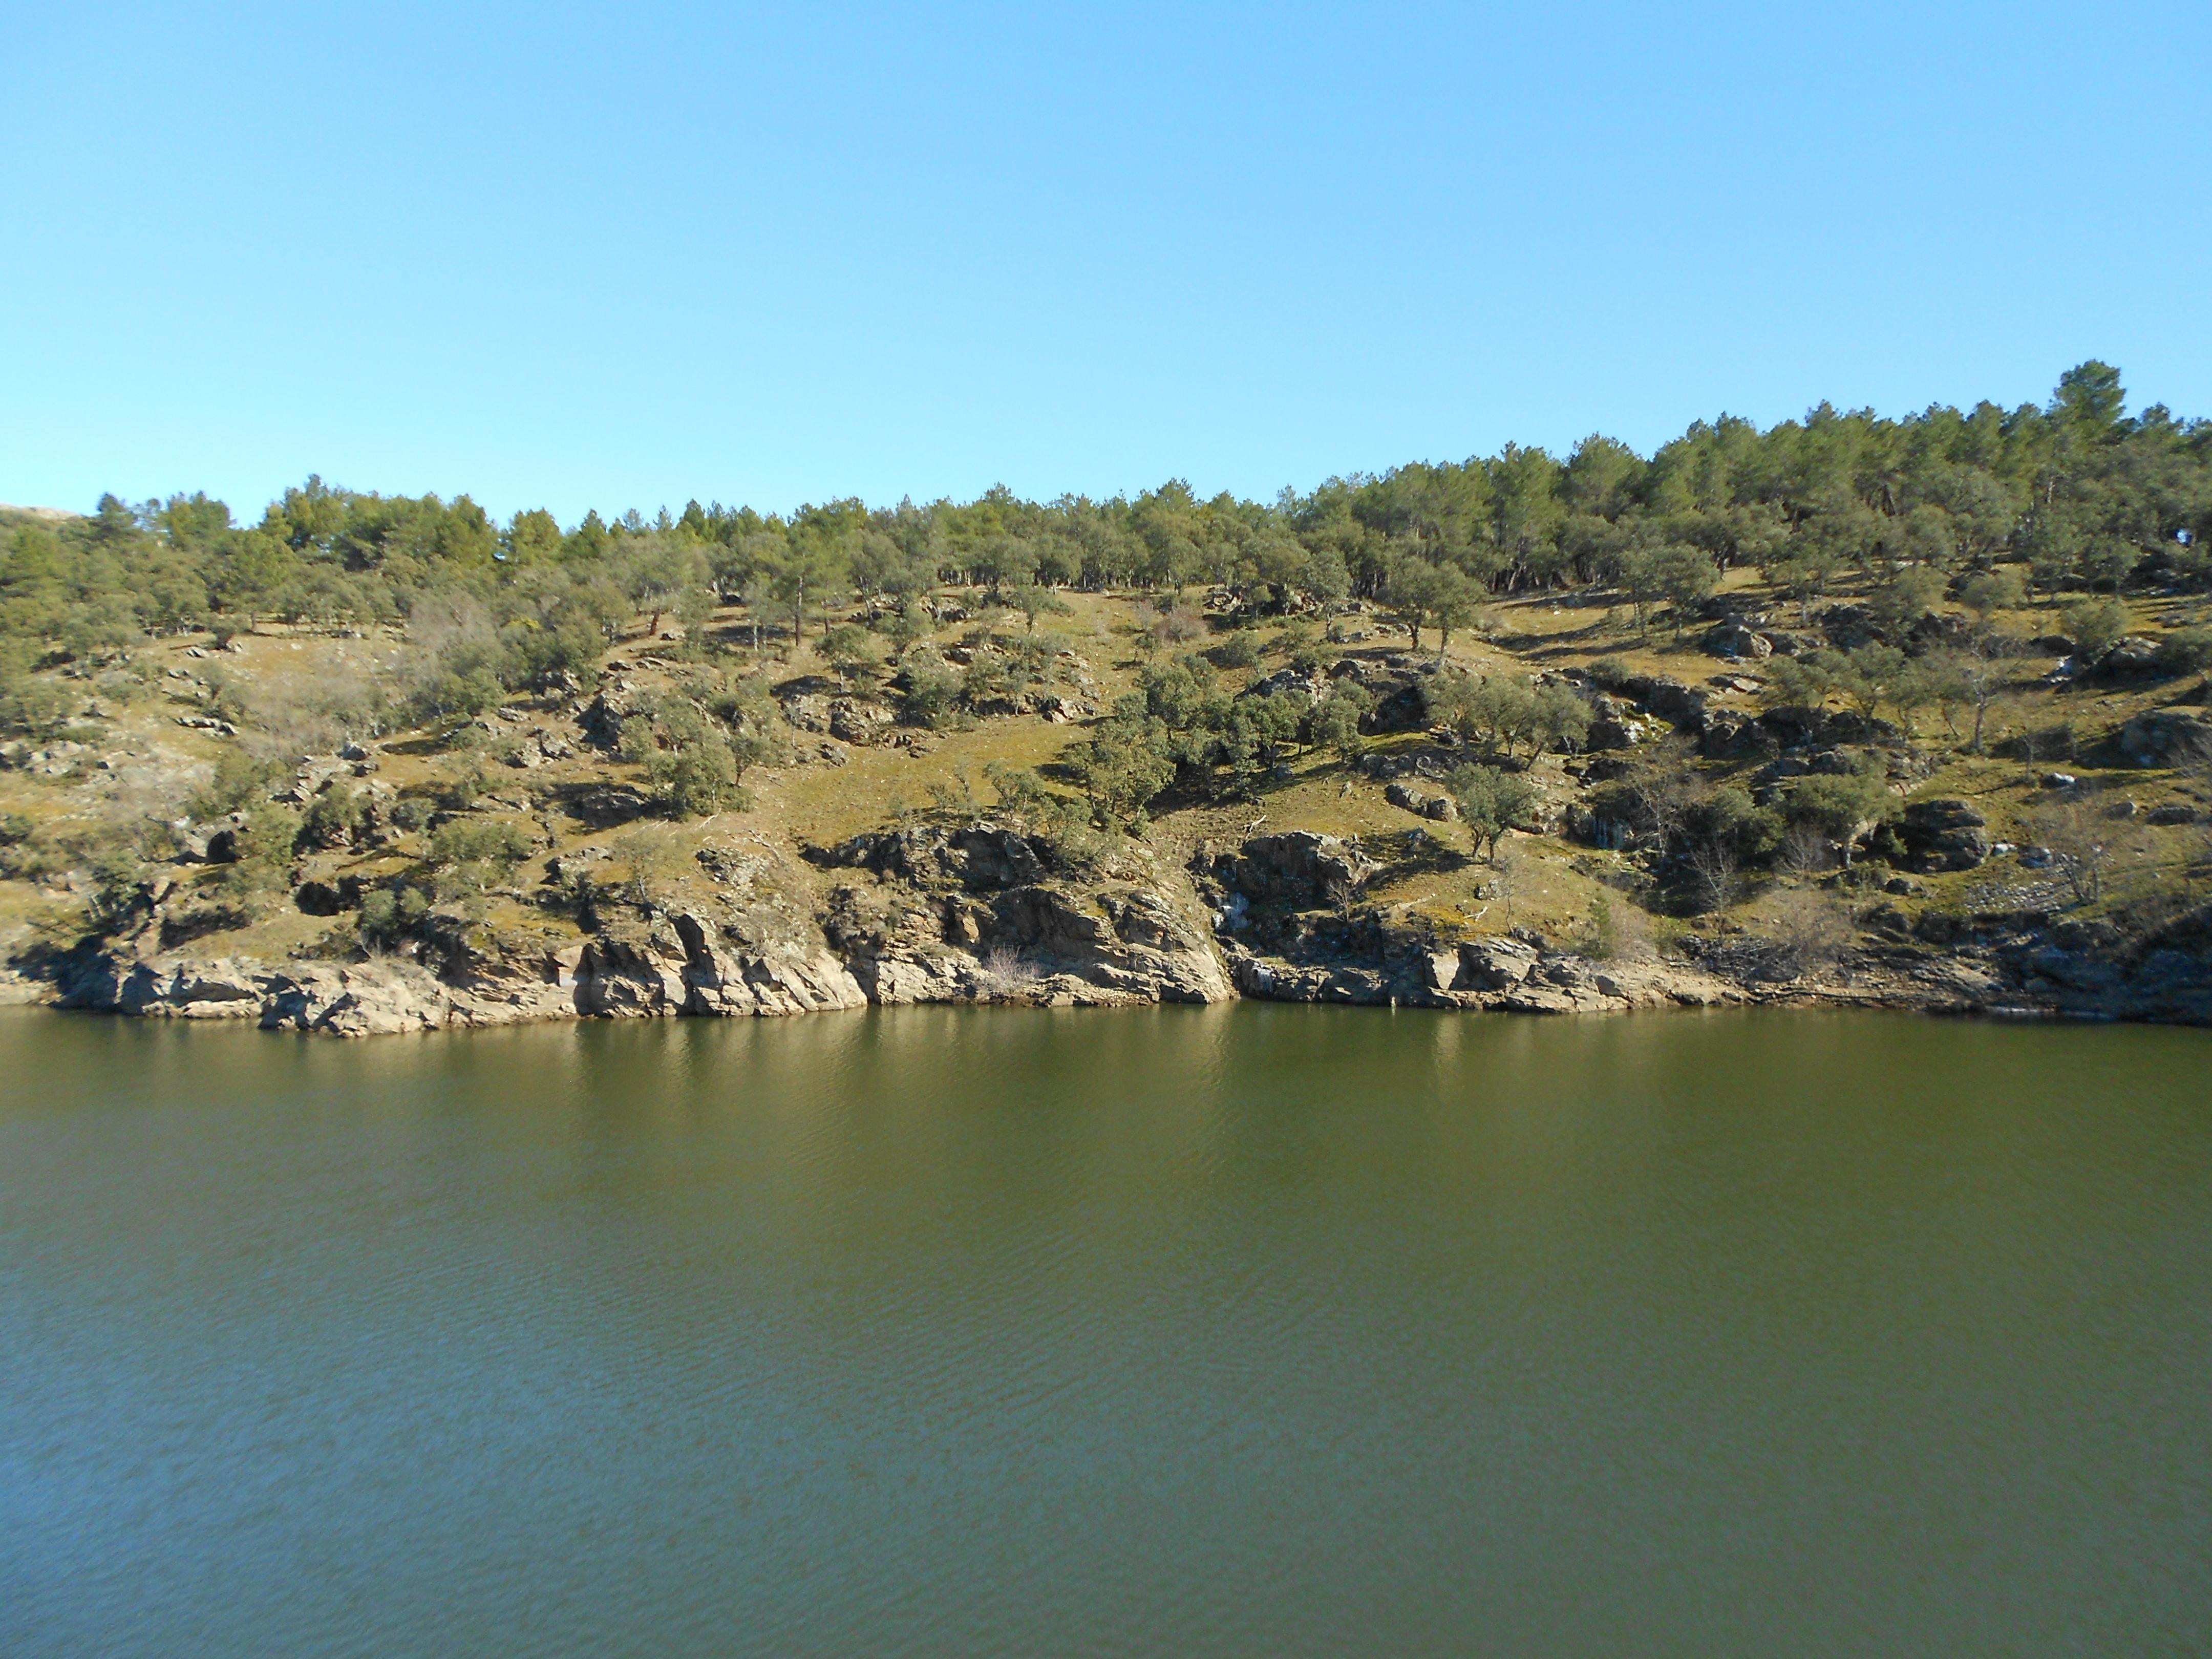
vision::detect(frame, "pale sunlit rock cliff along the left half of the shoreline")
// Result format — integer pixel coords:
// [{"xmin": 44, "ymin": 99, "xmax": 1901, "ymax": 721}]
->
[{"xmin": 57, "ymin": 823, "xmax": 1237, "ymax": 1037}]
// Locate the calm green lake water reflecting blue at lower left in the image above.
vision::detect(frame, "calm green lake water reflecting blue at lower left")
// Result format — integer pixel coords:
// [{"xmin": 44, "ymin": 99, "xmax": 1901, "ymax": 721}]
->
[{"xmin": 0, "ymin": 1004, "xmax": 2212, "ymax": 1659}]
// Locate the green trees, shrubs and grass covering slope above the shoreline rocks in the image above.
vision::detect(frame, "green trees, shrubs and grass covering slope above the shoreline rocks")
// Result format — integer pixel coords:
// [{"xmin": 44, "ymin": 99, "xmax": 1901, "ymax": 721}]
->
[{"xmin": 0, "ymin": 363, "xmax": 2212, "ymax": 1035}]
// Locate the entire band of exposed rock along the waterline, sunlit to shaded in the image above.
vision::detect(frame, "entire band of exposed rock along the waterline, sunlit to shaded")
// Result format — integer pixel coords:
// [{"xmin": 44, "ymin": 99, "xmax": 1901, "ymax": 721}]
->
[{"xmin": 34, "ymin": 801, "xmax": 2212, "ymax": 1037}]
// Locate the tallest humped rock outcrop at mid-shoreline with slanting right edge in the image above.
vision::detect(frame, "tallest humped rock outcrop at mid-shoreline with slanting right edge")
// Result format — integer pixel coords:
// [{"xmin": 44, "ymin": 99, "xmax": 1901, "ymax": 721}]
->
[{"xmin": 807, "ymin": 823, "xmax": 1232, "ymax": 1004}]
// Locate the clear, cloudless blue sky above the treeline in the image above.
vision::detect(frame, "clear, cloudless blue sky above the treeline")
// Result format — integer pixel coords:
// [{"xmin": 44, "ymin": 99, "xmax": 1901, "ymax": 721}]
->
[{"xmin": 0, "ymin": 0, "xmax": 2212, "ymax": 520}]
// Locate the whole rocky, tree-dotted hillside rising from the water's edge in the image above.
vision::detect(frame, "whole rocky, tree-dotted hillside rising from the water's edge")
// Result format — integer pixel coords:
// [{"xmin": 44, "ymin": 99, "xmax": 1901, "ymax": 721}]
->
[{"xmin": 0, "ymin": 371, "xmax": 2212, "ymax": 1031}]
